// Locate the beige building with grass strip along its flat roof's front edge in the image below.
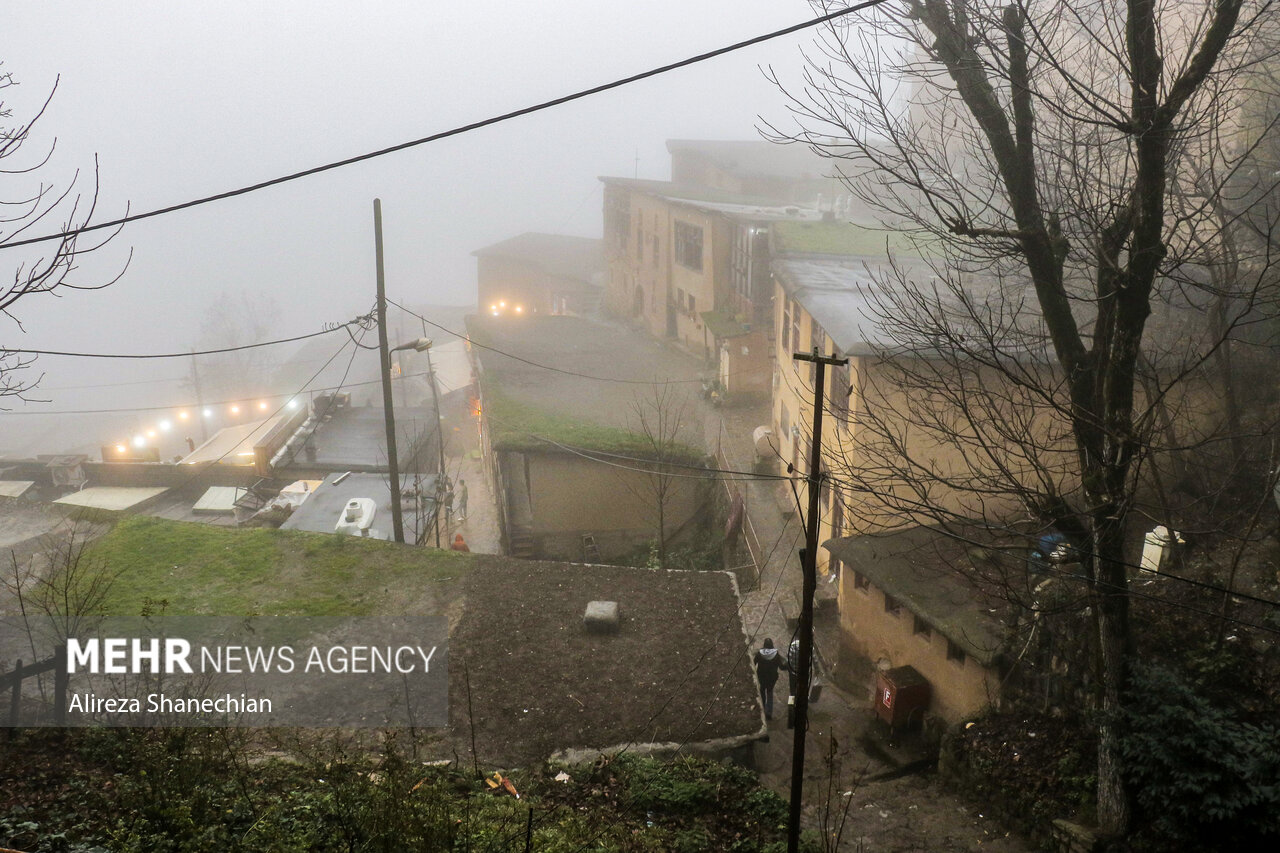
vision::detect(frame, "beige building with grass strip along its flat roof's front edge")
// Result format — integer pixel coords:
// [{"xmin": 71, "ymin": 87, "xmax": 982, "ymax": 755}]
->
[{"xmin": 467, "ymin": 308, "xmax": 716, "ymax": 562}]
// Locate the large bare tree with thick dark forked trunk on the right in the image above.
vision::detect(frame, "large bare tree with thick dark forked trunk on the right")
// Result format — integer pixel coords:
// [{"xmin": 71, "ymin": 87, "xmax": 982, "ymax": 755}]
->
[{"xmin": 771, "ymin": 0, "xmax": 1272, "ymax": 833}]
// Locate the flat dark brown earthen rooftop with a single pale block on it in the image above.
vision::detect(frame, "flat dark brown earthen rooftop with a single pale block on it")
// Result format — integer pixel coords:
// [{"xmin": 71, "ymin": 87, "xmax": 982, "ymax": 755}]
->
[{"xmin": 449, "ymin": 555, "xmax": 764, "ymax": 766}]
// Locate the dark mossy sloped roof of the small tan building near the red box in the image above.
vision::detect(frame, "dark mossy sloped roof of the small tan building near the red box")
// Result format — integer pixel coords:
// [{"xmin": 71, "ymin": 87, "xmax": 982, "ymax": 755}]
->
[{"xmin": 822, "ymin": 526, "xmax": 1009, "ymax": 666}]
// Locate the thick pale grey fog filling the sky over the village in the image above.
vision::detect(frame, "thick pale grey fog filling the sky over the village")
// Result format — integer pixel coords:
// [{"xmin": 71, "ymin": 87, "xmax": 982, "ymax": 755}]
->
[{"xmin": 0, "ymin": 0, "xmax": 813, "ymax": 455}]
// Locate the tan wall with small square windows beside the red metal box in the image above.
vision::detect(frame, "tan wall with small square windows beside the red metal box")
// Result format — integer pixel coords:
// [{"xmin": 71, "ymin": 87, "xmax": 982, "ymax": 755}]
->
[{"xmin": 840, "ymin": 571, "xmax": 1000, "ymax": 722}]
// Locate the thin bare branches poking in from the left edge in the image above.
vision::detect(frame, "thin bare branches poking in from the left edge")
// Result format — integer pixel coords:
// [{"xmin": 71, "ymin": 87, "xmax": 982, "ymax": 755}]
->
[{"xmin": 0, "ymin": 72, "xmax": 128, "ymax": 400}]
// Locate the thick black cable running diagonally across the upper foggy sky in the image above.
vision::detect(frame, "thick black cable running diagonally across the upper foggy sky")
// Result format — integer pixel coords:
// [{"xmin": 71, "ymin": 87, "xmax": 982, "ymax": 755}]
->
[{"xmin": 0, "ymin": 0, "xmax": 886, "ymax": 251}]
